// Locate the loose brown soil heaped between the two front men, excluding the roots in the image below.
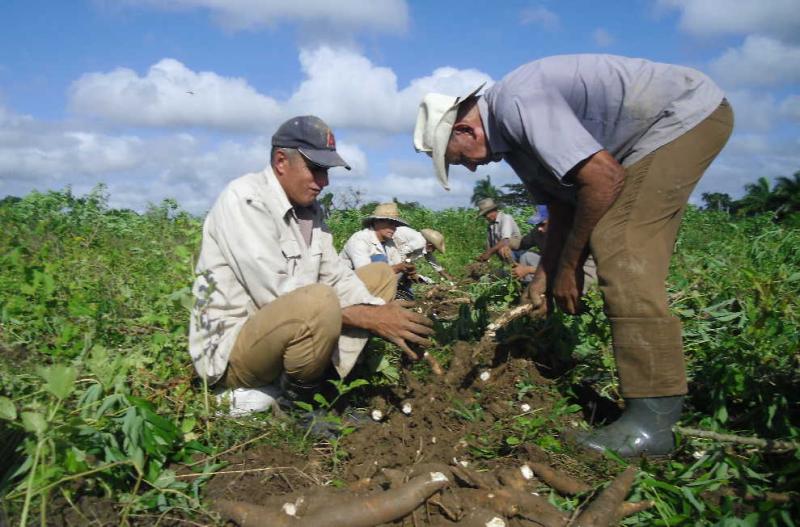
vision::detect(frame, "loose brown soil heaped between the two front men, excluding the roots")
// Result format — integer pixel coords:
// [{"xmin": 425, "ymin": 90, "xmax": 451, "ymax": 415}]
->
[{"xmin": 205, "ymin": 336, "xmax": 613, "ymax": 526}]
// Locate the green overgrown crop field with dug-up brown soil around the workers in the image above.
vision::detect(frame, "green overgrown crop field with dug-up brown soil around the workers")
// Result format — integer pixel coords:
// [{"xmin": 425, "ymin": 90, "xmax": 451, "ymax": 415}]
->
[{"xmin": 0, "ymin": 188, "xmax": 800, "ymax": 527}]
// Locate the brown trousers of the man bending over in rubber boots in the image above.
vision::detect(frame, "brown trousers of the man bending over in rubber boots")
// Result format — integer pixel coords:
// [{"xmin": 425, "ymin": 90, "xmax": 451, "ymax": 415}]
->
[{"xmin": 590, "ymin": 100, "xmax": 733, "ymax": 397}]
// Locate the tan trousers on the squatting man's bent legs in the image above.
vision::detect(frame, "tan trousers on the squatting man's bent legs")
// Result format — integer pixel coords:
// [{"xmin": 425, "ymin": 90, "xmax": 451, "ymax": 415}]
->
[{"xmin": 221, "ymin": 263, "xmax": 397, "ymax": 388}]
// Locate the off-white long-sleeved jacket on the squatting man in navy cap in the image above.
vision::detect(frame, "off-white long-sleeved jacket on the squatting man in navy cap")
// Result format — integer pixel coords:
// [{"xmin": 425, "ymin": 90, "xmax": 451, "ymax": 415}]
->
[{"xmin": 189, "ymin": 167, "xmax": 384, "ymax": 384}]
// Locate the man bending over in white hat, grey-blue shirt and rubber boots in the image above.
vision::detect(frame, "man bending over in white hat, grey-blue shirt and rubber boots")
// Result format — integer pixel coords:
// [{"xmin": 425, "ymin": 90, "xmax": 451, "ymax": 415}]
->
[{"xmin": 414, "ymin": 54, "xmax": 733, "ymax": 457}]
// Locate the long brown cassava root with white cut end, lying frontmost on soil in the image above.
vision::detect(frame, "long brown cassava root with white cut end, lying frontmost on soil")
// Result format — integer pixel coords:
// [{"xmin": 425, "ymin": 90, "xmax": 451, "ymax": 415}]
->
[{"xmin": 216, "ymin": 472, "xmax": 448, "ymax": 527}]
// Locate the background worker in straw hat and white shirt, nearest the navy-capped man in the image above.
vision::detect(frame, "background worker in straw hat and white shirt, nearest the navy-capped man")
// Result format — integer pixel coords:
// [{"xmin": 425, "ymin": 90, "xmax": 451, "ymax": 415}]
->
[{"xmin": 339, "ymin": 202, "xmax": 416, "ymax": 299}]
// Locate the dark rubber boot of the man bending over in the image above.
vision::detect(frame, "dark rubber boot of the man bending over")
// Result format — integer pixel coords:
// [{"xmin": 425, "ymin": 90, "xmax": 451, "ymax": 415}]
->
[{"xmin": 577, "ymin": 395, "xmax": 683, "ymax": 458}]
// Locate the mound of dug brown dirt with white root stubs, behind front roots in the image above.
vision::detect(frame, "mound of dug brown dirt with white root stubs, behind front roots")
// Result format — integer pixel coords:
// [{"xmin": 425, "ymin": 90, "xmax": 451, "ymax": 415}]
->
[{"xmin": 206, "ymin": 342, "xmax": 636, "ymax": 526}]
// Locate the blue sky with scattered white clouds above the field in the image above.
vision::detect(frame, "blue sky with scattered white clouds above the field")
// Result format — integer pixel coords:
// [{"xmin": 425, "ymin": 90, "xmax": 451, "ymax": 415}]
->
[{"xmin": 0, "ymin": 0, "xmax": 800, "ymax": 214}]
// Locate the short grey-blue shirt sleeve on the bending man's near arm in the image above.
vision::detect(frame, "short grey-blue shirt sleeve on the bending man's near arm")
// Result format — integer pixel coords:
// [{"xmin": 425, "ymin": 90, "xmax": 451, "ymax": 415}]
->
[{"xmin": 497, "ymin": 86, "xmax": 603, "ymax": 180}]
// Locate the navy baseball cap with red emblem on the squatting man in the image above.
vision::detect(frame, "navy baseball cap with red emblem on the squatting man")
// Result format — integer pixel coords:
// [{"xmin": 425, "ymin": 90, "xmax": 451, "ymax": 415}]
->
[{"xmin": 272, "ymin": 115, "xmax": 350, "ymax": 170}]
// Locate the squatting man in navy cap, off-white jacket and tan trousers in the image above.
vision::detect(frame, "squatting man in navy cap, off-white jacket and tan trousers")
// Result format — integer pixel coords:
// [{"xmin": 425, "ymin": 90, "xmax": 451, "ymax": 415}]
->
[{"xmin": 189, "ymin": 116, "xmax": 432, "ymax": 414}]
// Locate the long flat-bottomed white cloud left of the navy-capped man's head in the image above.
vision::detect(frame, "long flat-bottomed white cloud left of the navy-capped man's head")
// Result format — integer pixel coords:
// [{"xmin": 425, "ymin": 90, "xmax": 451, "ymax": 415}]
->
[{"xmin": 70, "ymin": 59, "xmax": 280, "ymax": 131}]
